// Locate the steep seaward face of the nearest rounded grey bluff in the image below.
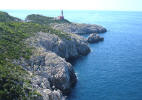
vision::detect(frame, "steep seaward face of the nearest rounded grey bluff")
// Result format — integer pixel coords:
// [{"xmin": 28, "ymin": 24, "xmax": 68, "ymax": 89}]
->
[{"xmin": 45, "ymin": 53, "xmax": 76, "ymax": 93}]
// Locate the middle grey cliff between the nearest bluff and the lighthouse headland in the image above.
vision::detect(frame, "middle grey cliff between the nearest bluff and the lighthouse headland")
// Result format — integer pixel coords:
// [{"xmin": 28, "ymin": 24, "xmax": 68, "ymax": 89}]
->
[{"xmin": 29, "ymin": 32, "xmax": 90, "ymax": 59}]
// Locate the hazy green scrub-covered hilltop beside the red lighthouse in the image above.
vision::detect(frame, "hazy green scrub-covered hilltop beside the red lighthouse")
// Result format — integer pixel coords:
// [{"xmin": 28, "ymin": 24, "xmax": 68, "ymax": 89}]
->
[{"xmin": 26, "ymin": 14, "xmax": 71, "ymax": 25}]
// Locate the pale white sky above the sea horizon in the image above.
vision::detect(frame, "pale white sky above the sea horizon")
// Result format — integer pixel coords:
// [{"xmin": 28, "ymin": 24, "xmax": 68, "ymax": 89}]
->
[{"xmin": 0, "ymin": 0, "xmax": 142, "ymax": 11}]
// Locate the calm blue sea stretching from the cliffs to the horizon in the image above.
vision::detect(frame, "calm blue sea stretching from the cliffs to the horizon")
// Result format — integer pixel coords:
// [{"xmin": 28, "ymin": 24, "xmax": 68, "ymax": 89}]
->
[{"xmin": 3, "ymin": 10, "xmax": 142, "ymax": 100}]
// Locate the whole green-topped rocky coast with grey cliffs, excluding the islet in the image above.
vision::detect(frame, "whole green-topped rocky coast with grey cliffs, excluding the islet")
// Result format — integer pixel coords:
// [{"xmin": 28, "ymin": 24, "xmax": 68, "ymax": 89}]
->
[{"xmin": 0, "ymin": 12, "xmax": 106, "ymax": 100}]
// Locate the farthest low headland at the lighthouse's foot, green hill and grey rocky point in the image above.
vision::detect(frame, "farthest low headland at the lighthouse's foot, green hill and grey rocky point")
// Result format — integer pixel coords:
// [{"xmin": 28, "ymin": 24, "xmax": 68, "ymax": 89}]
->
[{"xmin": 25, "ymin": 14, "xmax": 107, "ymax": 34}]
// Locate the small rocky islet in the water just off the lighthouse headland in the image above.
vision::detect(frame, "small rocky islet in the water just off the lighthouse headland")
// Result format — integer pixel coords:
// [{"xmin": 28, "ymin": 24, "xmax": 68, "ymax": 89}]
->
[{"xmin": 87, "ymin": 33, "xmax": 104, "ymax": 43}]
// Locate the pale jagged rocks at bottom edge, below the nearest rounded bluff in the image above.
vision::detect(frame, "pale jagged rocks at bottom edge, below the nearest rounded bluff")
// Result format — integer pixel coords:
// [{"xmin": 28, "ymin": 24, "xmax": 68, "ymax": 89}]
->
[{"xmin": 32, "ymin": 74, "xmax": 66, "ymax": 100}]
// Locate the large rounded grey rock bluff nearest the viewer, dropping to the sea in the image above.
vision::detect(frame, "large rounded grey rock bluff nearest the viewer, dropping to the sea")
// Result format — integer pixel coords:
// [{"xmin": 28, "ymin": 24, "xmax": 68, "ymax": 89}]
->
[{"xmin": 29, "ymin": 51, "xmax": 76, "ymax": 93}]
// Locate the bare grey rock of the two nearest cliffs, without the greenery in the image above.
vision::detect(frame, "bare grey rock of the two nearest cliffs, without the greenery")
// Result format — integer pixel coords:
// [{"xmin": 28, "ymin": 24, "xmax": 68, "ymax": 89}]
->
[{"xmin": 21, "ymin": 32, "xmax": 90, "ymax": 100}]
